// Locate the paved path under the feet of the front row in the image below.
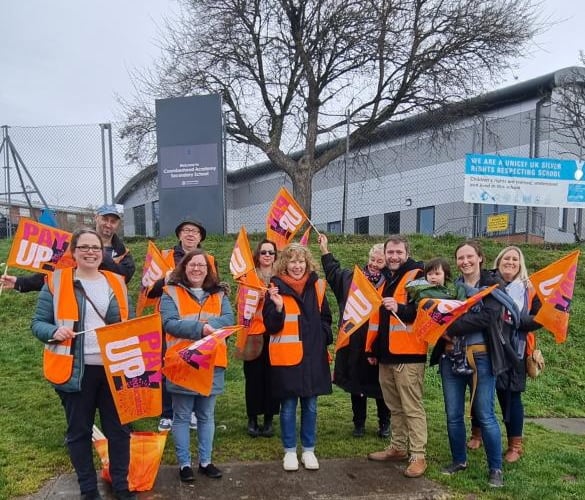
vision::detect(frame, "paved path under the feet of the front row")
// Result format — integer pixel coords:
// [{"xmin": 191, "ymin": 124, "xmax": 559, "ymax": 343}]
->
[{"xmin": 15, "ymin": 418, "xmax": 585, "ymax": 500}]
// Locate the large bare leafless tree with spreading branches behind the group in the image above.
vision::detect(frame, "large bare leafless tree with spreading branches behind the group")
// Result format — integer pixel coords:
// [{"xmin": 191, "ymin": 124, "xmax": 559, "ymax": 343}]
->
[{"xmin": 122, "ymin": 0, "xmax": 540, "ymax": 214}]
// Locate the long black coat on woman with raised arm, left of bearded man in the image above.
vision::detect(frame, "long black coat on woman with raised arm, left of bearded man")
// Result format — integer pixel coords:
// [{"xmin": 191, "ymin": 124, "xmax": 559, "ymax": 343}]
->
[{"xmin": 321, "ymin": 253, "xmax": 384, "ymax": 399}]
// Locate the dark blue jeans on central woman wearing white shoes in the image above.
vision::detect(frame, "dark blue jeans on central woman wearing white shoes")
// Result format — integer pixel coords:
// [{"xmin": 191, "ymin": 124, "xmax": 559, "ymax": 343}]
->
[{"xmin": 280, "ymin": 396, "xmax": 317, "ymax": 452}]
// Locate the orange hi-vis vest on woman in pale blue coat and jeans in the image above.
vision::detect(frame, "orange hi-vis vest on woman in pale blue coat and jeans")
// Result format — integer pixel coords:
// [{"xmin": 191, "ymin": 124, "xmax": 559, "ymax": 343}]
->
[{"xmin": 165, "ymin": 285, "xmax": 227, "ymax": 368}]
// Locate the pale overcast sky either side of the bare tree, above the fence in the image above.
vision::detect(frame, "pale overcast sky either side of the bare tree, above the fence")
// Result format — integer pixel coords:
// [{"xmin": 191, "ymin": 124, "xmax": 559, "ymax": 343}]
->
[{"xmin": 0, "ymin": 0, "xmax": 585, "ymax": 126}]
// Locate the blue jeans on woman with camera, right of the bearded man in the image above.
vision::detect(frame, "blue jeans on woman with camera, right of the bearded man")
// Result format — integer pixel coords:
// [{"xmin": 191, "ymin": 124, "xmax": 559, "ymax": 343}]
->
[{"xmin": 439, "ymin": 353, "xmax": 502, "ymax": 470}]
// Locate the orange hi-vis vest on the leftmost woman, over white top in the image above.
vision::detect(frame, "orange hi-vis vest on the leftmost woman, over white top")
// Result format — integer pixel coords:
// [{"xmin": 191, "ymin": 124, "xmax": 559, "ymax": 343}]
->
[{"xmin": 43, "ymin": 267, "xmax": 129, "ymax": 385}]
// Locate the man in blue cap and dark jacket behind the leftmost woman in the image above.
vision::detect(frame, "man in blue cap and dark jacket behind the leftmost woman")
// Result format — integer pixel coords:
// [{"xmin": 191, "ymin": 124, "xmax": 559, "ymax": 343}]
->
[{"xmin": 0, "ymin": 205, "xmax": 135, "ymax": 293}]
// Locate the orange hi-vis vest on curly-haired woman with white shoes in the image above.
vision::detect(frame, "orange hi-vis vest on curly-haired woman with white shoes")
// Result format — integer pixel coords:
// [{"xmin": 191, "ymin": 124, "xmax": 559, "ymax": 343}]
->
[{"xmin": 268, "ymin": 279, "xmax": 326, "ymax": 366}]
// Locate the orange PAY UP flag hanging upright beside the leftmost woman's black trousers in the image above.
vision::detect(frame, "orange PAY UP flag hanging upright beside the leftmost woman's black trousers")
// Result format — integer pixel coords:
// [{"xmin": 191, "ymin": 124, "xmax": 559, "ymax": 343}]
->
[{"xmin": 96, "ymin": 314, "xmax": 162, "ymax": 424}]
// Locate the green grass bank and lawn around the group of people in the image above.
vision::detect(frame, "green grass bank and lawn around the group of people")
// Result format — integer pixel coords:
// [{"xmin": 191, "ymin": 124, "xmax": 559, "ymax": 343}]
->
[{"xmin": 0, "ymin": 235, "xmax": 585, "ymax": 499}]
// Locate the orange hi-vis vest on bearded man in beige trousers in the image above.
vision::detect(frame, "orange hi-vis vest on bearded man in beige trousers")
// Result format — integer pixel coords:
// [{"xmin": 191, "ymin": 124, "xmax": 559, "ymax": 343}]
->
[{"xmin": 365, "ymin": 269, "xmax": 428, "ymax": 355}]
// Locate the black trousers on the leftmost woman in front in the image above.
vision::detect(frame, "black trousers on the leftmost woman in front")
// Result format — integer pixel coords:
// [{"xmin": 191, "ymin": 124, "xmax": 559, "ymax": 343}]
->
[{"xmin": 57, "ymin": 365, "xmax": 130, "ymax": 493}]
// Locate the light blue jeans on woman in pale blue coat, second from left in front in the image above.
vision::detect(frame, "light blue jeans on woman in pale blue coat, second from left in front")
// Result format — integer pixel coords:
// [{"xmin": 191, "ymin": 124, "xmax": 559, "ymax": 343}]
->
[{"xmin": 172, "ymin": 393, "xmax": 216, "ymax": 467}]
